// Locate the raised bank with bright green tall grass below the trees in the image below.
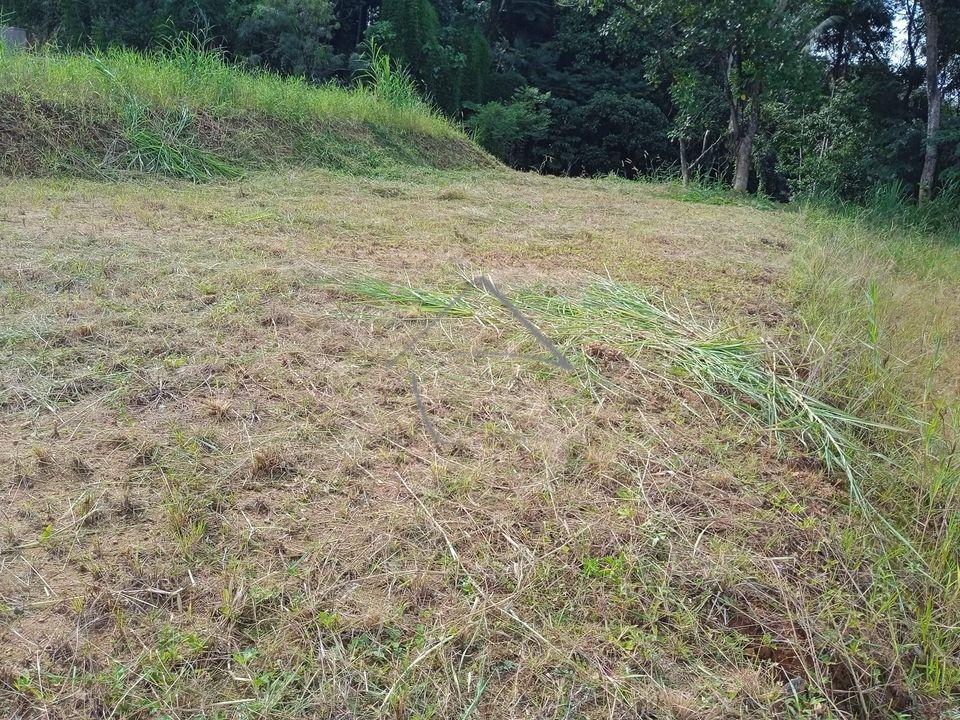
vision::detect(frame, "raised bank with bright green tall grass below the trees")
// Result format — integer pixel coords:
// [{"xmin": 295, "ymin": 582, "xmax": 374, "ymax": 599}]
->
[{"xmin": 0, "ymin": 40, "xmax": 494, "ymax": 181}]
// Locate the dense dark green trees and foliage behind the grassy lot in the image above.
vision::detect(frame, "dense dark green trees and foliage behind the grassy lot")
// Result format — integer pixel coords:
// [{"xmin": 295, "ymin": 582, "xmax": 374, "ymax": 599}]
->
[{"xmin": 0, "ymin": 0, "xmax": 960, "ymax": 199}]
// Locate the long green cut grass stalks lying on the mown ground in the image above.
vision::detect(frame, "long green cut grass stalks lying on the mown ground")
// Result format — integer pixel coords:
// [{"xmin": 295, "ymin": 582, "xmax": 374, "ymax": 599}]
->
[{"xmin": 338, "ymin": 279, "xmax": 876, "ymax": 500}]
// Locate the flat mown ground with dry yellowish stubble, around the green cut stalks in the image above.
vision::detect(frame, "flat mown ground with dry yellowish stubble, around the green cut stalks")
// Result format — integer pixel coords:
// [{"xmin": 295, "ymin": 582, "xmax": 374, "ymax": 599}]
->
[{"xmin": 0, "ymin": 171, "xmax": 957, "ymax": 718}]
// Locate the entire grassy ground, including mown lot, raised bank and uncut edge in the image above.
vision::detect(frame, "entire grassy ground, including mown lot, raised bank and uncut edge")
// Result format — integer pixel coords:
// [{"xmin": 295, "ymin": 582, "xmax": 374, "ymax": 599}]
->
[{"xmin": 0, "ymin": 45, "xmax": 960, "ymax": 720}]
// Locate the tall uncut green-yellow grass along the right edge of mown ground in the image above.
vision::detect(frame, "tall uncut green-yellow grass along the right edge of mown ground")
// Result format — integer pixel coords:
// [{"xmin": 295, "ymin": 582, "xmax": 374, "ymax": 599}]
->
[{"xmin": 794, "ymin": 202, "xmax": 960, "ymax": 694}]
